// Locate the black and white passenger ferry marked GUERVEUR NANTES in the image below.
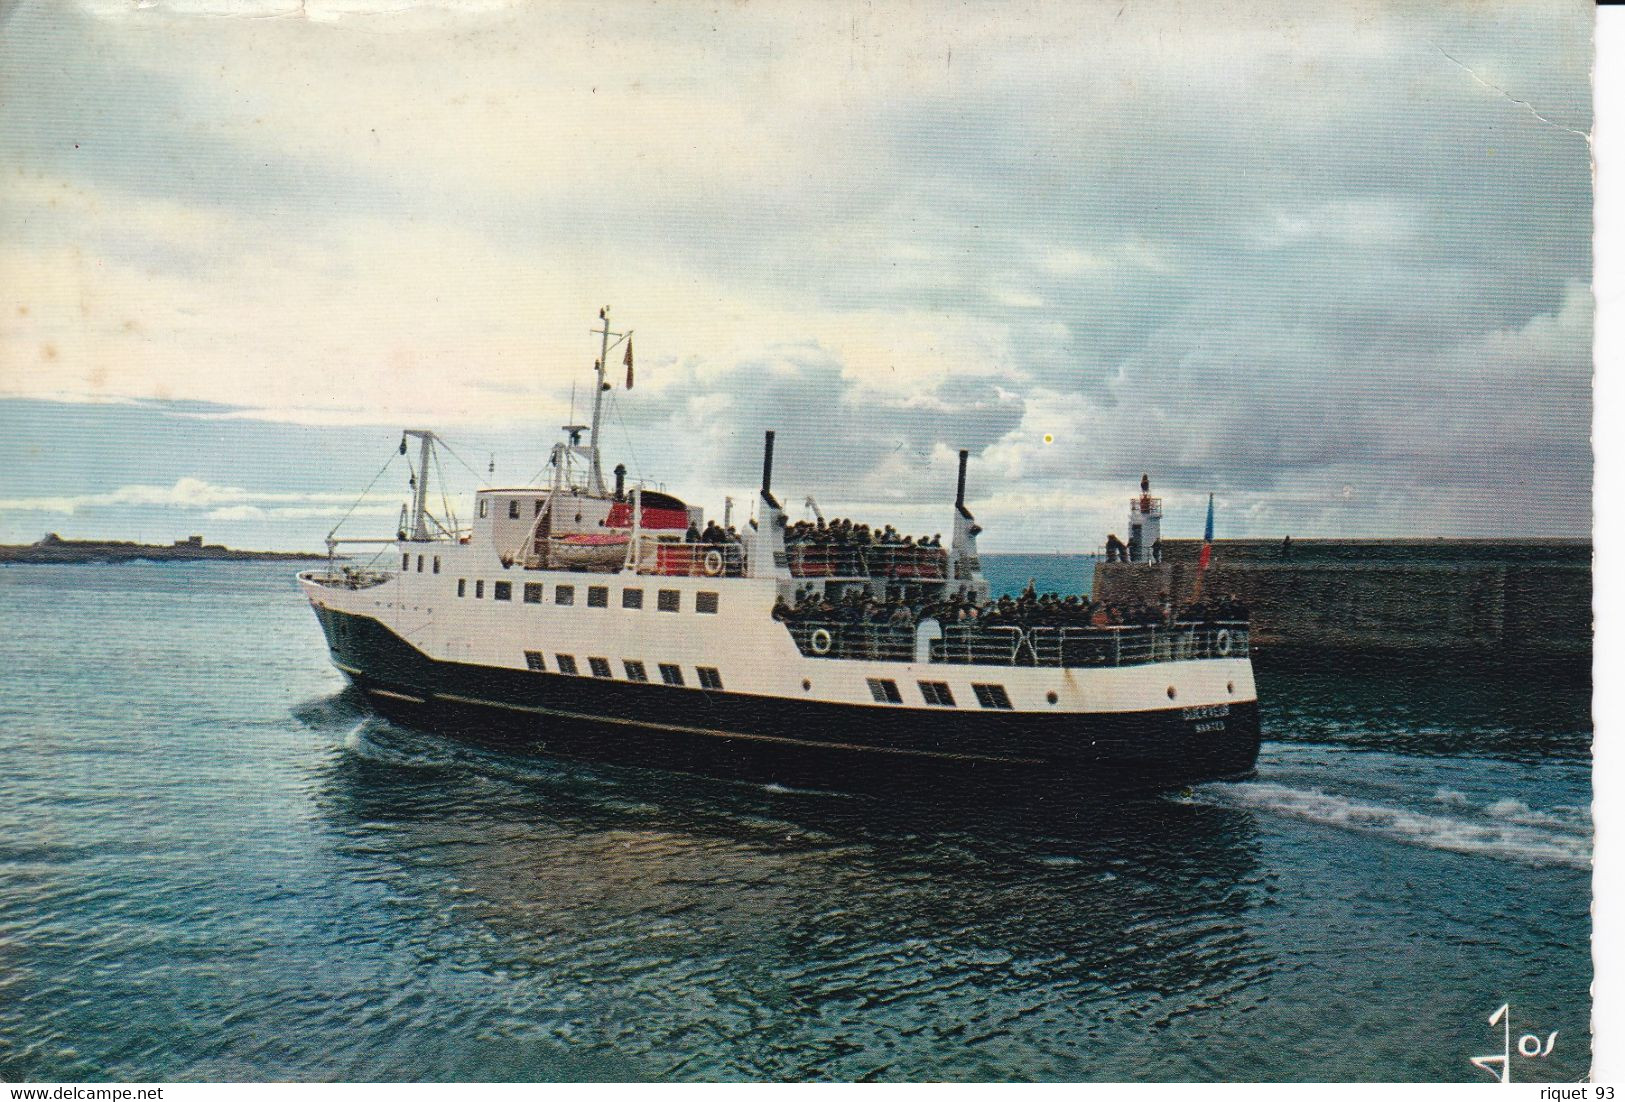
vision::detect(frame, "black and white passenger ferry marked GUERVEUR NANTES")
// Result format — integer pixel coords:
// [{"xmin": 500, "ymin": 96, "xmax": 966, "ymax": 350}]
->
[{"xmin": 299, "ymin": 309, "xmax": 1259, "ymax": 792}]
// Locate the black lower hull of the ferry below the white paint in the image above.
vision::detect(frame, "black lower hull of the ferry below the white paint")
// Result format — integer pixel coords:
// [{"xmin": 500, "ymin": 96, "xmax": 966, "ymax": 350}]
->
[{"xmin": 315, "ymin": 606, "xmax": 1259, "ymax": 795}]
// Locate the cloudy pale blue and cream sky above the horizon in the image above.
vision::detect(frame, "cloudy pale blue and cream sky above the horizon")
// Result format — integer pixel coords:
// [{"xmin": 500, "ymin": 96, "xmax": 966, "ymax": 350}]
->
[{"xmin": 0, "ymin": 0, "xmax": 1593, "ymax": 549}]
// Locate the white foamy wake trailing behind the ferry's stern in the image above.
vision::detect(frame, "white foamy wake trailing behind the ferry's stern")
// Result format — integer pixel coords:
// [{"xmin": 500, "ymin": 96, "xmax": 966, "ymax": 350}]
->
[{"xmin": 1201, "ymin": 782, "xmax": 1591, "ymax": 868}]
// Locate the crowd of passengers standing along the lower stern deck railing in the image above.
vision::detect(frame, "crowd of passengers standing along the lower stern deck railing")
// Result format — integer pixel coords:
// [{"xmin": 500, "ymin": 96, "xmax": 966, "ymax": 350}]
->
[{"xmin": 774, "ymin": 582, "xmax": 1248, "ymax": 629}]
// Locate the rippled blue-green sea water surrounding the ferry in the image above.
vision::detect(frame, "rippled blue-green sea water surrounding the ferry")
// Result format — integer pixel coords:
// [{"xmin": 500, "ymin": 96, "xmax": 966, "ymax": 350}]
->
[{"xmin": 0, "ymin": 556, "xmax": 1591, "ymax": 1081}]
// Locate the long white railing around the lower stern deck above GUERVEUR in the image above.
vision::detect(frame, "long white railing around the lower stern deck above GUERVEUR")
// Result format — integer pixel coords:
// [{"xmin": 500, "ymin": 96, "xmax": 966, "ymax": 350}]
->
[{"xmin": 785, "ymin": 619, "xmax": 1250, "ymax": 668}]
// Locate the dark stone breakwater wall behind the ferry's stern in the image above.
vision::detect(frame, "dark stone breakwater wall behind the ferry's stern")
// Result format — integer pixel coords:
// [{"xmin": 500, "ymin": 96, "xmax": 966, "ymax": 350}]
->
[{"xmin": 1092, "ymin": 540, "xmax": 1591, "ymax": 675}]
